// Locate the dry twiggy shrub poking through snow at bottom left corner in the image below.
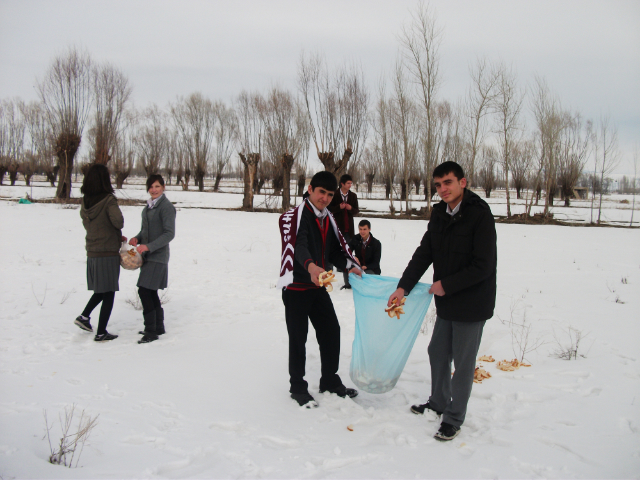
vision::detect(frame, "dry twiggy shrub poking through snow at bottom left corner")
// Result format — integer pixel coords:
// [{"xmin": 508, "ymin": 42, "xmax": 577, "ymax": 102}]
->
[{"xmin": 43, "ymin": 403, "xmax": 99, "ymax": 468}]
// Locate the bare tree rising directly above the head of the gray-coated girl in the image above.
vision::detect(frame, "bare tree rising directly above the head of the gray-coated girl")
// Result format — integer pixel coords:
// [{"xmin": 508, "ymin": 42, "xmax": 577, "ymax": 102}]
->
[{"xmin": 136, "ymin": 104, "xmax": 169, "ymax": 176}]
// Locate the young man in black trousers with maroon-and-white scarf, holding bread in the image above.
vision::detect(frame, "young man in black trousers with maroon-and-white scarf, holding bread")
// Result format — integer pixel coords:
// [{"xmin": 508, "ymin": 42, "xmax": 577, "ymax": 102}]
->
[{"xmin": 282, "ymin": 171, "xmax": 360, "ymax": 408}]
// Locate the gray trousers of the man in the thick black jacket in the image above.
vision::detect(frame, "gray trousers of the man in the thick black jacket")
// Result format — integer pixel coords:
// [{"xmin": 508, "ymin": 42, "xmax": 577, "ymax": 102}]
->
[{"xmin": 428, "ymin": 316, "xmax": 485, "ymax": 427}]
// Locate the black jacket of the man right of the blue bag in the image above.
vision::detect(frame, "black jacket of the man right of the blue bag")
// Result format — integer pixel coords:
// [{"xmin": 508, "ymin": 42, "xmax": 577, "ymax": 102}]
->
[{"xmin": 398, "ymin": 189, "xmax": 497, "ymax": 322}]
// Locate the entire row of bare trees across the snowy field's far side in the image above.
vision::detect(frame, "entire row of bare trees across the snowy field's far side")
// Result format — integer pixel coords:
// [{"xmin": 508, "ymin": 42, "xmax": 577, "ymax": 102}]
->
[{"xmin": 0, "ymin": 3, "xmax": 618, "ymax": 220}]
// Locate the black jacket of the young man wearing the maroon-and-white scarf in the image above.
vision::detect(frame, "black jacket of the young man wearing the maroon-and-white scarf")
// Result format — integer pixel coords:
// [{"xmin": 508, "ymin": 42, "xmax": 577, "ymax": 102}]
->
[{"xmin": 287, "ymin": 200, "xmax": 347, "ymax": 290}]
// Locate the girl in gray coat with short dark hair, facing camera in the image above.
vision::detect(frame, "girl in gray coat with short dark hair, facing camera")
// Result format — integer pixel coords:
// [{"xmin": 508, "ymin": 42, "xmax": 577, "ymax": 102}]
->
[{"xmin": 129, "ymin": 175, "xmax": 176, "ymax": 343}]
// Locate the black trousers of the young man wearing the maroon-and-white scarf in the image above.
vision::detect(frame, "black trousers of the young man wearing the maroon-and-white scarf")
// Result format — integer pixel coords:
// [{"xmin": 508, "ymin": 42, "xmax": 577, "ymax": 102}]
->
[{"xmin": 282, "ymin": 288, "xmax": 342, "ymax": 393}]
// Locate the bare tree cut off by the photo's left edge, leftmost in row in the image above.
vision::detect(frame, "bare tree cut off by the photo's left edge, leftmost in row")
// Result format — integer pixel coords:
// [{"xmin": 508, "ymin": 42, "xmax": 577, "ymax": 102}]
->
[{"xmin": 0, "ymin": 98, "xmax": 26, "ymax": 185}]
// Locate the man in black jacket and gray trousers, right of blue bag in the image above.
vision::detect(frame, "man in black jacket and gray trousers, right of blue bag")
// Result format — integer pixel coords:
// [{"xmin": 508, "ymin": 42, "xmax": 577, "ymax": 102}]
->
[{"xmin": 388, "ymin": 162, "xmax": 497, "ymax": 441}]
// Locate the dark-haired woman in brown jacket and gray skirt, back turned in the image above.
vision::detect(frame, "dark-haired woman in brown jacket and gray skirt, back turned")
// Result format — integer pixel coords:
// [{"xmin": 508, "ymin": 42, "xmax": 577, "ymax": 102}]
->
[{"xmin": 74, "ymin": 165, "xmax": 127, "ymax": 342}]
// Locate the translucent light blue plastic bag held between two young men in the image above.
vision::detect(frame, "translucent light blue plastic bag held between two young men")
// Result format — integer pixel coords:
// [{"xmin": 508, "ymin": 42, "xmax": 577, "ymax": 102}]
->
[{"xmin": 349, "ymin": 274, "xmax": 433, "ymax": 393}]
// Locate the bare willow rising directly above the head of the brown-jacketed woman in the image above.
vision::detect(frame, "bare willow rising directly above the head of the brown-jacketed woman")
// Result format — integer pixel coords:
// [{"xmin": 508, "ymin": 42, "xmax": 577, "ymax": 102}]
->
[{"xmin": 88, "ymin": 63, "xmax": 132, "ymax": 165}]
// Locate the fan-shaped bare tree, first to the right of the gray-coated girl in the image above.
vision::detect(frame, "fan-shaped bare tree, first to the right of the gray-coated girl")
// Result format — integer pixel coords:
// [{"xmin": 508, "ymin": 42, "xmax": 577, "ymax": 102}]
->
[{"xmin": 171, "ymin": 93, "xmax": 217, "ymax": 192}]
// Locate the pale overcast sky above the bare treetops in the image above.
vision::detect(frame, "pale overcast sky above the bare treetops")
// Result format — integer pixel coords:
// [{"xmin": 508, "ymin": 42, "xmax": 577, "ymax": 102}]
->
[{"xmin": 0, "ymin": 0, "xmax": 640, "ymax": 172}]
